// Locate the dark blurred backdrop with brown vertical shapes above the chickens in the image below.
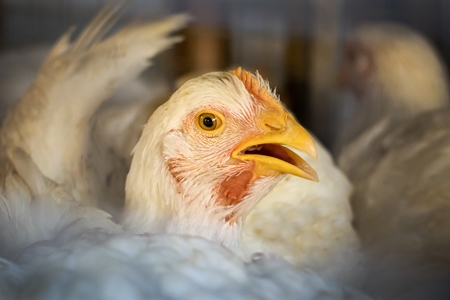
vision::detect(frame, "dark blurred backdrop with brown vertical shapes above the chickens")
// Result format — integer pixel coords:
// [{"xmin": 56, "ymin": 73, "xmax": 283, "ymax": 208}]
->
[{"xmin": 0, "ymin": 0, "xmax": 450, "ymax": 147}]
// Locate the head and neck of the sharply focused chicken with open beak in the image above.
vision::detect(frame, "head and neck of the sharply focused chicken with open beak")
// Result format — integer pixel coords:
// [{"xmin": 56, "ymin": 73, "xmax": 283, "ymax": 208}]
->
[{"xmin": 123, "ymin": 68, "xmax": 317, "ymax": 248}]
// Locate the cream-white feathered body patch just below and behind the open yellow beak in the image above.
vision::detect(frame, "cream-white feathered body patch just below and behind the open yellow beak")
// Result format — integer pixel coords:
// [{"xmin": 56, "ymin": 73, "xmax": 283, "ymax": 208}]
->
[{"xmin": 242, "ymin": 139, "xmax": 364, "ymax": 286}]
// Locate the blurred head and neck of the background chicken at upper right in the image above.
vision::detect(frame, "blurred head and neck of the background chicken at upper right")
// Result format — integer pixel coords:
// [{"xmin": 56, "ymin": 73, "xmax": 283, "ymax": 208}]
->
[{"xmin": 337, "ymin": 23, "xmax": 449, "ymax": 154}]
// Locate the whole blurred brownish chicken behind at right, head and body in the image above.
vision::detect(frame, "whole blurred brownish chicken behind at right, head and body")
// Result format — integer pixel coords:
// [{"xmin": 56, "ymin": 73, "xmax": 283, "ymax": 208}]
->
[{"xmin": 338, "ymin": 24, "xmax": 450, "ymax": 299}]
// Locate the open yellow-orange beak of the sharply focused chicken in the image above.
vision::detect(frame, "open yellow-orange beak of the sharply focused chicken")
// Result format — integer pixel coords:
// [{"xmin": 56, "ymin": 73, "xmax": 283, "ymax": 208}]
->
[{"xmin": 231, "ymin": 112, "xmax": 318, "ymax": 181}]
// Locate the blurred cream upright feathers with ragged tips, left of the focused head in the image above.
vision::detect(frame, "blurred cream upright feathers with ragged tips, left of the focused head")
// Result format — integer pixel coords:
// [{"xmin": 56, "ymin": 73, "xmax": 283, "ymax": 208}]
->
[{"xmin": 0, "ymin": 6, "xmax": 188, "ymax": 209}]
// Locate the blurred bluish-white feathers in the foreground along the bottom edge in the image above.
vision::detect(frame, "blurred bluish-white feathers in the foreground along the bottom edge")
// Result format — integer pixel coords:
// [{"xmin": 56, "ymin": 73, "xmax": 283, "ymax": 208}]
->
[{"xmin": 0, "ymin": 231, "xmax": 369, "ymax": 300}]
